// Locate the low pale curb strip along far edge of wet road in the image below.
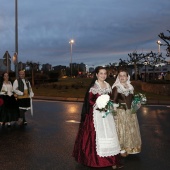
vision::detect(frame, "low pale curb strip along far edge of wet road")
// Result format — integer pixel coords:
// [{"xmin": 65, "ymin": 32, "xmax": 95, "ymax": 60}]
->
[{"xmin": 34, "ymin": 96, "xmax": 170, "ymax": 105}]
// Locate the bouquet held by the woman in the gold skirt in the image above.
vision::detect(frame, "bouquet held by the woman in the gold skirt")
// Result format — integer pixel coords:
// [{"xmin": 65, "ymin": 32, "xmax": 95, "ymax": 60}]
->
[{"xmin": 131, "ymin": 93, "xmax": 147, "ymax": 114}]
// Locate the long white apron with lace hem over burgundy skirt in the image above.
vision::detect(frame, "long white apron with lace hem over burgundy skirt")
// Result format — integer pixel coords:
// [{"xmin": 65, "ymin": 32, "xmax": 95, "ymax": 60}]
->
[{"xmin": 93, "ymin": 107, "xmax": 120, "ymax": 157}]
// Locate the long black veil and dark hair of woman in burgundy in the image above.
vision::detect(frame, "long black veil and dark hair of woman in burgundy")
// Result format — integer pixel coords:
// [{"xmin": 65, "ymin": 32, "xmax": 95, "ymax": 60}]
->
[{"xmin": 81, "ymin": 66, "xmax": 106, "ymax": 122}]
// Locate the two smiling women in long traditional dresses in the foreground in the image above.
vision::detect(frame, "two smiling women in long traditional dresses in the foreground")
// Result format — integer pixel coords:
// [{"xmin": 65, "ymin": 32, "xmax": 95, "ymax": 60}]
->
[{"xmin": 72, "ymin": 66, "xmax": 141, "ymax": 169}]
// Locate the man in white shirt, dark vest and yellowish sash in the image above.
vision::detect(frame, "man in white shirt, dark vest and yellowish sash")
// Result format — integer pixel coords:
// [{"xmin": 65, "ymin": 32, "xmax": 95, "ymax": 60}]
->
[{"xmin": 13, "ymin": 70, "xmax": 34, "ymax": 125}]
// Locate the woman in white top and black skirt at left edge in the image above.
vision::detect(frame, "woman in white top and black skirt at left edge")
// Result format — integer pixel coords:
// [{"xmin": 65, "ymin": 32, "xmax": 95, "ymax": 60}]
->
[{"xmin": 0, "ymin": 73, "xmax": 19, "ymax": 127}]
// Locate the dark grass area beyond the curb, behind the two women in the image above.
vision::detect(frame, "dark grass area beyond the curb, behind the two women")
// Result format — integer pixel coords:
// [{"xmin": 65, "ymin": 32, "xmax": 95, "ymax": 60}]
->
[{"xmin": 33, "ymin": 78, "xmax": 169, "ymax": 100}]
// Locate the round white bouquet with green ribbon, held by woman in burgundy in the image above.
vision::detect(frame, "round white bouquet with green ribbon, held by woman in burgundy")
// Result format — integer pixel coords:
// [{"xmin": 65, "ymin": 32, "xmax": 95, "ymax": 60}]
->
[{"xmin": 96, "ymin": 94, "xmax": 118, "ymax": 118}]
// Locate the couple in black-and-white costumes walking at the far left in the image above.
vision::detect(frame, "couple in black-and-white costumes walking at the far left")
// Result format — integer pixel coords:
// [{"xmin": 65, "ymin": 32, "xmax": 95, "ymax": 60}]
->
[{"xmin": 0, "ymin": 70, "xmax": 34, "ymax": 127}]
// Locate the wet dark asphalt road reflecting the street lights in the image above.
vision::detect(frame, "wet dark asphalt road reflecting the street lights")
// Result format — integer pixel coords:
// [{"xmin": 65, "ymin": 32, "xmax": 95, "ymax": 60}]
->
[{"xmin": 0, "ymin": 100, "xmax": 170, "ymax": 170}]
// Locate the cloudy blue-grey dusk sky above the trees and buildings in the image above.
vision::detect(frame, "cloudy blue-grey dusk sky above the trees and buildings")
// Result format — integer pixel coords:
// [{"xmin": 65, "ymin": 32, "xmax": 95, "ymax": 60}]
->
[{"xmin": 0, "ymin": 0, "xmax": 170, "ymax": 67}]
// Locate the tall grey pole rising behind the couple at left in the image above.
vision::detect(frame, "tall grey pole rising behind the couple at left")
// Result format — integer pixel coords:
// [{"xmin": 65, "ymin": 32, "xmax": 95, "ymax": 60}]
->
[{"xmin": 15, "ymin": 0, "xmax": 18, "ymax": 78}]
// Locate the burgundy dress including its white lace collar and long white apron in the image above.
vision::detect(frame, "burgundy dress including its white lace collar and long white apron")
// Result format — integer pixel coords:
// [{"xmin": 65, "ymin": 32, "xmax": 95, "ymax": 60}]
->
[{"xmin": 73, "ymin": 80, "xmax": 120, "ymax": 167}]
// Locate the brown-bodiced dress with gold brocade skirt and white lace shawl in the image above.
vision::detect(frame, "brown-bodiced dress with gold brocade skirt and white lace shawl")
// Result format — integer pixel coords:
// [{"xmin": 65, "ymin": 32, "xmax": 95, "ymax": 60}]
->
[{"xmin": 111, "ymin": 76, "xmax": 141, "ymax": 154}]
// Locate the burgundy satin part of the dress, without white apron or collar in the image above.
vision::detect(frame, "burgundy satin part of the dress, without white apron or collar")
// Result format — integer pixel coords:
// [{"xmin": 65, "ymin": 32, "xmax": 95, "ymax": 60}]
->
[{"xmin": 73, "ymin": 81, "xmax": 119, "ymax": 167}]
